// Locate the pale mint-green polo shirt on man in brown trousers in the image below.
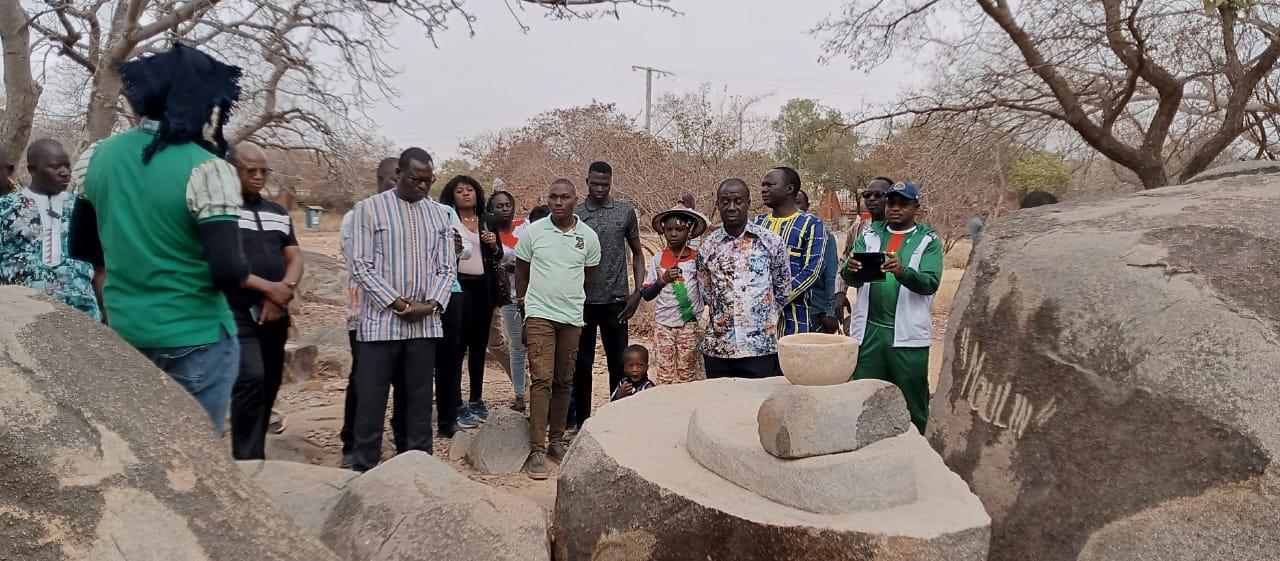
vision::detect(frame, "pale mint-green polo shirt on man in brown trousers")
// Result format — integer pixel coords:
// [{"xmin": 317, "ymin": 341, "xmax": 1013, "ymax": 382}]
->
[{"xmin": 516, "ymin": 216, "xmax": 600, "ymax": 327}]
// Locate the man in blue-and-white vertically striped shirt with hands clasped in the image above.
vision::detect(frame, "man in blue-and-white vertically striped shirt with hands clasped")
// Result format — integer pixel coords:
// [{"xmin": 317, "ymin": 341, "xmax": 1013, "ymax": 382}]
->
[{"xmin": 347, "ymin": 149, "xmax": 457, "ymax": 471}]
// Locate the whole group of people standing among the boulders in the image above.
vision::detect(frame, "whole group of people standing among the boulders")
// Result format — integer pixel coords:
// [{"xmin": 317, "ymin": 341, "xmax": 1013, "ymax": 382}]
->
[{"xmin": 0, "ymin": 45, "xmax": 942, "ymax": 479}]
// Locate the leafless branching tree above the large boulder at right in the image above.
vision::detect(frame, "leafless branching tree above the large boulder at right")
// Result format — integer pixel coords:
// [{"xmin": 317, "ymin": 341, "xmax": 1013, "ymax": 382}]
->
[{"xmin": 817, "ymin": 0, "xmax": 1280, "ymax": 188}]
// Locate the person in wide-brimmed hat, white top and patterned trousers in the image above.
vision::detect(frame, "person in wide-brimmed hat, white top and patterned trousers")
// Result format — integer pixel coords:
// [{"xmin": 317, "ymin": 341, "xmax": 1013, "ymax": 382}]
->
[{"xmin": 641, "ymin": 206, "xmax": 707, "ymax": 384}]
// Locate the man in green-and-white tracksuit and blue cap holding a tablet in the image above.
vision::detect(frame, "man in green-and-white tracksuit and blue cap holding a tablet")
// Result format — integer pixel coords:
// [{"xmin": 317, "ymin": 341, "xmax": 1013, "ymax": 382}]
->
[{"xmin": 841, "ymin": 182, "xmax": 942, "ymax": 433}]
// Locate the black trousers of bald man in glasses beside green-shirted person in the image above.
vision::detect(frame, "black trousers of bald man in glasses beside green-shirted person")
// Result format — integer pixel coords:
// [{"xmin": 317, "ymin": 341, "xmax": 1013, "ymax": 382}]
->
[{"xmin": 230, "ymin": 310, "xmax": 289, "ymax": 460}]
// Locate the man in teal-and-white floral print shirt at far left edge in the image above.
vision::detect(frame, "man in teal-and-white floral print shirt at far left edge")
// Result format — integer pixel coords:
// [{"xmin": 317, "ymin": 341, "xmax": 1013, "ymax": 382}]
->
[{"xmin": 0, "ymin": 138, "xmax": 102, "ymax": 320}]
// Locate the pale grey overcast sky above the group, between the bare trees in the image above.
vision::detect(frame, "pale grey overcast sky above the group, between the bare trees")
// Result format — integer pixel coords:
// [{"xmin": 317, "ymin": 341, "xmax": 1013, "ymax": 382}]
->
[{"xmin": 375, "ymin": 0, "xmax": 924, "ymax": 158}]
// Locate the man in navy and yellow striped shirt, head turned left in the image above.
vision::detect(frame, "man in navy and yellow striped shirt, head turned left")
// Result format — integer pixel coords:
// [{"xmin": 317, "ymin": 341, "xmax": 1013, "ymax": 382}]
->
[{"xmin": 755, "ymin": 167, "xmax": 827, "ymax": 336}]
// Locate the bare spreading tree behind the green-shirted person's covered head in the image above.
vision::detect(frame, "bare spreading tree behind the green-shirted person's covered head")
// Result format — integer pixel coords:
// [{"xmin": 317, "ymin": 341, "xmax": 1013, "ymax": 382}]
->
[{"xmin": 0, "ymin": 0, "xmax": 668, "ymax": 162}]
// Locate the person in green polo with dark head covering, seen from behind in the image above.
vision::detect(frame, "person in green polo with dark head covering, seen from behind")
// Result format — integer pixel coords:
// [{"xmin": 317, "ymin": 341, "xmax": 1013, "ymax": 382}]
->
[{"xmin": 70, "ymin": 44, "xmax": 293, "ymax": 434}]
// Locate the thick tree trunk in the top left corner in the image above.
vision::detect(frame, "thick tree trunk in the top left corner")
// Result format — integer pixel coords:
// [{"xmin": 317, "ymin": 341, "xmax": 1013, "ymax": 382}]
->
[{"xmin": 0, "ymin": 0, "xmax": 42, "ymax": 164}]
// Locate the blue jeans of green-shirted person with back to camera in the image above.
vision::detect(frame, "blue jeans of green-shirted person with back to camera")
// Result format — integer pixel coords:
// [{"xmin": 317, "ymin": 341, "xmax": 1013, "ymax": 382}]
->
[{"xmin": 138, "ymin": 328, "xmax": 239, "ymax": 437}]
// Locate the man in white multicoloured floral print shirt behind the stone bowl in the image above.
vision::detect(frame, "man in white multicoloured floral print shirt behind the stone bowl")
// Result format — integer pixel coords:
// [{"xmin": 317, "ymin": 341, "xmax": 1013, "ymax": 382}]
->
[{"xmin": 698, "ymin": 179, "xmax": 791, "ymax": 378}]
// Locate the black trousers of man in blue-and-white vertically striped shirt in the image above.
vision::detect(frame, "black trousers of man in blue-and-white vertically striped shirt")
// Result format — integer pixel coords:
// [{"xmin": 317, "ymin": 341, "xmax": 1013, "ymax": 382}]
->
[{"xmin": 351, "ymin": 339, "xmax": 439, "ymax": 471}]
